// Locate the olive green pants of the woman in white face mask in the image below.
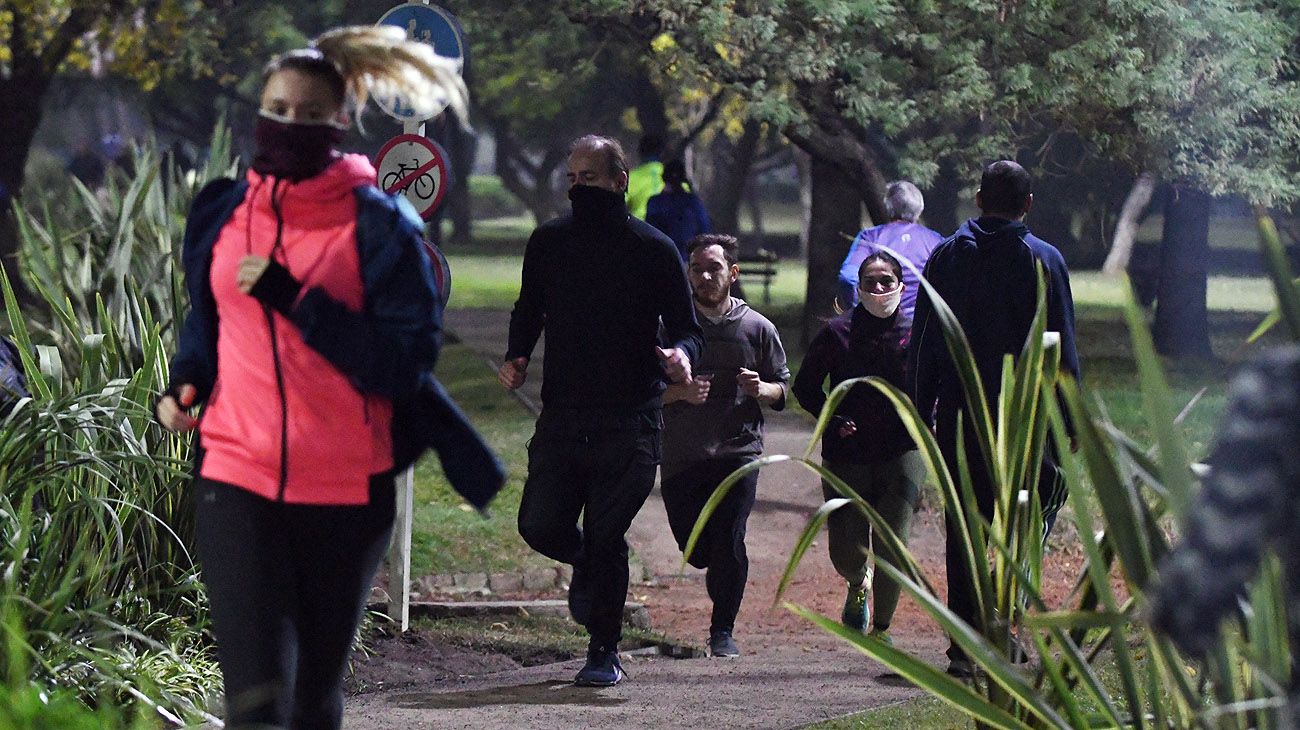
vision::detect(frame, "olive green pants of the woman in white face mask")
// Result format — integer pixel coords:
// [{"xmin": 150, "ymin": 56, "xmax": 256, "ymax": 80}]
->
[{"xmin": 822, "ymin": 451, "xmax": 926, "ymax": 629}]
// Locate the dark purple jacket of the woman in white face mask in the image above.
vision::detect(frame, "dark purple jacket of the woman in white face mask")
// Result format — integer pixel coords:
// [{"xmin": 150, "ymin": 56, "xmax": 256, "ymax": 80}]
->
[{"xmin": 790, "ymin": 307, "xmax": 917, "ymax": 464}]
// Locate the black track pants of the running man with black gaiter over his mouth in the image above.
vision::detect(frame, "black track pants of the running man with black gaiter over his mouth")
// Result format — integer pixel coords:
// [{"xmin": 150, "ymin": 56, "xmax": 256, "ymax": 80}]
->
[{"xmin": 519, "ymin": 408, "xmax": 663, "ymax": 649}]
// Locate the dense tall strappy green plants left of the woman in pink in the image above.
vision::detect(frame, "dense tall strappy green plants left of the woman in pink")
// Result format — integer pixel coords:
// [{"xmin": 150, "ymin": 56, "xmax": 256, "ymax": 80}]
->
[{"xmin": 0, "ymin": 131, "xmax": 228, "ymax": 724}]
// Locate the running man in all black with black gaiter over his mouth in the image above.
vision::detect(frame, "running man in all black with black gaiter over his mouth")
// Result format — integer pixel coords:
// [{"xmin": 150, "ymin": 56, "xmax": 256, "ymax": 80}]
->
[{"xmin": 498, "ymin": 135, "xmax": 703, "ymax": 686}]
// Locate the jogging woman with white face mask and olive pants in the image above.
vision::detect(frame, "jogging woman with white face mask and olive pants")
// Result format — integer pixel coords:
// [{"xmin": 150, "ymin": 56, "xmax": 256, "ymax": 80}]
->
[{"xmin": 792, "ymin": 252, "xmax": 926, "ymax": 643}]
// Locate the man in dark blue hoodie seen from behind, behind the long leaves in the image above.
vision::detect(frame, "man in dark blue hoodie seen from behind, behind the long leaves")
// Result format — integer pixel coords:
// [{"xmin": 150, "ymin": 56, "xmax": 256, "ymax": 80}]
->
[{"xmin": 909, "ymin": 160, "xmax": 1079, "ymax": 677}]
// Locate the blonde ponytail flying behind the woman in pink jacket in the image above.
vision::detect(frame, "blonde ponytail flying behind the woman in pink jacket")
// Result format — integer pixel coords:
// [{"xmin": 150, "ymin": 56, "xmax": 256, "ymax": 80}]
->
[{"xmin": 312, "ymin": 26, "xmax": 469, "ymax": 123}]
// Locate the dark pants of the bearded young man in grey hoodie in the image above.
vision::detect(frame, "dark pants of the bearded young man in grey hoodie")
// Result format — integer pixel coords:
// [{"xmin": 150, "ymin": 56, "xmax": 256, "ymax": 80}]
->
[{"xmin": 659, "ymin": 456, "xmax": 758, "ymax": 631}]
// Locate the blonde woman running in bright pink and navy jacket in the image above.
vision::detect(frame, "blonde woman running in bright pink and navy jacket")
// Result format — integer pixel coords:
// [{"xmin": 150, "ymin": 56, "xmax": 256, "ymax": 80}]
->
[{"xmin": 157, "ymin": 26, "xmax": 464, "ymax": 729}]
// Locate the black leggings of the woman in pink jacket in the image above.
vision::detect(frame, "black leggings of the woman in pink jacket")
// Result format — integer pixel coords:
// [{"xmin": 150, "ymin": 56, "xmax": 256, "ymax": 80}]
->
[{"xmin": 195, "ymin": 475, "xmax": 395, "ymax": 730}]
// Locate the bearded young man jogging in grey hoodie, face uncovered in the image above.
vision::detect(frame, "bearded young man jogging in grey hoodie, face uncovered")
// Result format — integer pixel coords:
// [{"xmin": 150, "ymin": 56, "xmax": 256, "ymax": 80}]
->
[{"xmin": 660, "ymin": 234, "xmax": 790, "ymax": 657}]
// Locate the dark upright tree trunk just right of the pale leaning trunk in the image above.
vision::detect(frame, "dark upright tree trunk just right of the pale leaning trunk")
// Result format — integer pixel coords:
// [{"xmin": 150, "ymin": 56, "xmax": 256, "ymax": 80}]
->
[{"xmin": 1152, "ymin": 186, "xmax": 1214, "ymax": 359}]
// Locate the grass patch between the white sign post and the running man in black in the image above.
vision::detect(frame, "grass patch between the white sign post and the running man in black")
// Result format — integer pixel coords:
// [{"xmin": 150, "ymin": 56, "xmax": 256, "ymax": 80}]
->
[{"xmin": 411, "ymin": 344, "xmax": 554, "ymax": 575}]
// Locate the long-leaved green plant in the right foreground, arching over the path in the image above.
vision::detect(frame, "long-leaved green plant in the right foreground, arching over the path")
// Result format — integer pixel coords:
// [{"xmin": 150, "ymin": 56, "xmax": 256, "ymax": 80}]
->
[{"xmin": 686, "ymin": 214, "xmax": 1300, "ymax": 730}]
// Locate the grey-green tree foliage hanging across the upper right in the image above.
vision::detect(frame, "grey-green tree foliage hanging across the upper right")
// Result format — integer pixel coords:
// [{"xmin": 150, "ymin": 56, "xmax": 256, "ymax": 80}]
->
[{"xmin": 582, "ymin": 0, "xmax": 1300, "ymax": 200}]
